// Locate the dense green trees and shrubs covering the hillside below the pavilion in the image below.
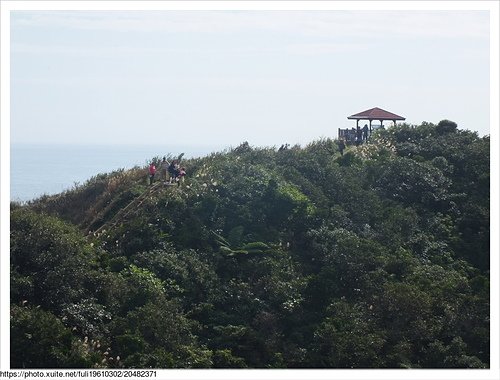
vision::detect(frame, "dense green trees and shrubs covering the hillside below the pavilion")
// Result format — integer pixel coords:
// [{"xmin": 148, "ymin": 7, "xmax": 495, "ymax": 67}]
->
[{"xmin": 10, "ymin": 120, "xmax": 490, "ymax": 368}]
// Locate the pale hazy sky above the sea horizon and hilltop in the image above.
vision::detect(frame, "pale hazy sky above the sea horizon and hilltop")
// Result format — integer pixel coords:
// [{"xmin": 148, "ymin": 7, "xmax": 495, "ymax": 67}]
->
[{"xmin": 11, "ymin": 11, "xmax": 490, "ymax": 147}]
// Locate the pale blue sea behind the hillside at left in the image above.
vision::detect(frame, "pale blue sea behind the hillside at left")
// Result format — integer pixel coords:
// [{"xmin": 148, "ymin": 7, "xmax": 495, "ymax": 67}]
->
[{"xmin": 10, "ymin": 144, "xmax": 221, "ymax": 203}]
